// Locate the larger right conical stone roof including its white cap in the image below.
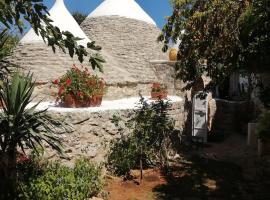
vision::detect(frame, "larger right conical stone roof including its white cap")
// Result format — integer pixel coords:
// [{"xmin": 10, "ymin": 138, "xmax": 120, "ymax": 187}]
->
[{"xmin": 81, "ymin": 0, "xmax": 167, "ymax": 85}]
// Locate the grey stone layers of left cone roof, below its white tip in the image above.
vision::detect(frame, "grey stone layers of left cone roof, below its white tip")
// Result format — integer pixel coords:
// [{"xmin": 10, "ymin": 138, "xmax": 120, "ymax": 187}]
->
[{"xmin": 8, "ymin": 42, "xmax": 84, "ymax": 83}]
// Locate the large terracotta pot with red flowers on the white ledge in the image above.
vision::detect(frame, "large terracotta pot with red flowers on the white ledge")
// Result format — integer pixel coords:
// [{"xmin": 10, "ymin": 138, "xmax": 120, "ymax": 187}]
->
[{"xmin": 53, "ymin": 65, "xmax": 106, "ymax": 108}]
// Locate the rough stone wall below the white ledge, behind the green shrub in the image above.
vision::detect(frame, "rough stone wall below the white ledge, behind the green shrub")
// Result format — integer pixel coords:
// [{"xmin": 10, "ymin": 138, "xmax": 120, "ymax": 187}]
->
[{"xmin": 46, "ymin": 101, "xmax": 186, "ymax": 164}]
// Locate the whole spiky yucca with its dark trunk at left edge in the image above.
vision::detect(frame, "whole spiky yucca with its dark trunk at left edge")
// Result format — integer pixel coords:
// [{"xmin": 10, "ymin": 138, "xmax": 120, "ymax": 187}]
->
[{"xmin": 0, "ymin": 72, "xmax": 65, "ymax": 199}]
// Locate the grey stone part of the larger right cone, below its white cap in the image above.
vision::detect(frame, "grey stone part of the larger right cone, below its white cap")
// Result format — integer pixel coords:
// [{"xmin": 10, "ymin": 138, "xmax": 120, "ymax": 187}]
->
[{"xmin": 81, "ymin": 16, "xmax": 167, "ymax": 83}]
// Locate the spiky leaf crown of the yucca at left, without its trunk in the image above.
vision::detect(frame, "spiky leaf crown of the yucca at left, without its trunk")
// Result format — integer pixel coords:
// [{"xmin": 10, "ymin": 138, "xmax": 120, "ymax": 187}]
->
[{"xmin": 0, "ymin": 72, "xmax": 67, "ymax": 153}]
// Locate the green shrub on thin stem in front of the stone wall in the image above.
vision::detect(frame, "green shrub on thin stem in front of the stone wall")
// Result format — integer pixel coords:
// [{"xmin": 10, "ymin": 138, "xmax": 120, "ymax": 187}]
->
[{"xmin": 107, "ymin": 98, "xmax": 174, "ymax": 177}]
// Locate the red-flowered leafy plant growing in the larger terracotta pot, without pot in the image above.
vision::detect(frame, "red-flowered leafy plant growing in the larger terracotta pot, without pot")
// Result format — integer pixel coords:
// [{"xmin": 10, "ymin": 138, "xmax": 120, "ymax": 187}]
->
[{"xmin": 53, "ymin": 65, "xmax": 106, "ymax": 101}]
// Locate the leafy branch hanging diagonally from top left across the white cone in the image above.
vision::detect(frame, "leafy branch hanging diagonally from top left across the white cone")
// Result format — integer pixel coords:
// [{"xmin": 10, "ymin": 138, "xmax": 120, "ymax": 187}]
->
[{"xmin": 0, "ymin": 0, "xmax": 105, "ymax": 71}]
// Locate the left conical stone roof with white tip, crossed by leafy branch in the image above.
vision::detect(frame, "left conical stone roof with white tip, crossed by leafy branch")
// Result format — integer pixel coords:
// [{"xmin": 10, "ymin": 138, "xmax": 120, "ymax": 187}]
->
[{"xmin": 9, "ymin": 0, "xmax": 90, "ymax": 82}]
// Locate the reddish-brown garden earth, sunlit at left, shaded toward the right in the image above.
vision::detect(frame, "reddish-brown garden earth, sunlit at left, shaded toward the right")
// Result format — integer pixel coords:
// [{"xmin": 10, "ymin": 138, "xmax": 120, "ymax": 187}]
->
[{"xmin": 106, "ymin": 134, "xmax": 270, "ymax": 200}]
